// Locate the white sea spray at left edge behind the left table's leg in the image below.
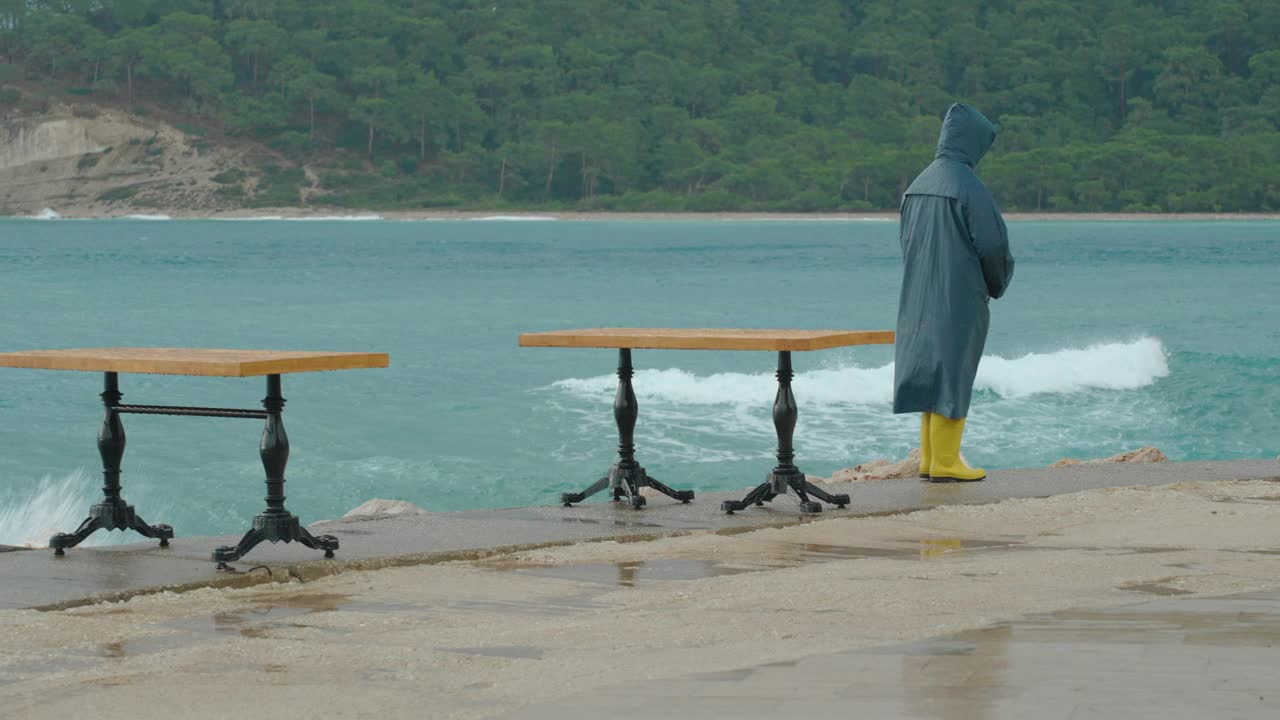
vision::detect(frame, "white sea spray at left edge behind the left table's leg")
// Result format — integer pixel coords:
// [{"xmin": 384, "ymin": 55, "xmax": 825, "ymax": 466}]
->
[{"xmin": 0, "ymin": 470, "xmax": 105, "ymax": 547}]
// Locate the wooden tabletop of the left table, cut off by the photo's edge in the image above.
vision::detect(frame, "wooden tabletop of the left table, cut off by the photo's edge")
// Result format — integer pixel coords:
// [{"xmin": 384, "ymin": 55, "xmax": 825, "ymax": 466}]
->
[{"xmin": 0, "ymin": 347, "xmax": 389, "ymax": 378}]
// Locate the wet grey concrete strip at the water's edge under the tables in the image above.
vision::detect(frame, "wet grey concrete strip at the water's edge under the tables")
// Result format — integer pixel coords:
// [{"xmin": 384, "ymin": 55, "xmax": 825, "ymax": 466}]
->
[{"xmin": 0, "ymin": 460, "xmax": 1280, "ymax": 609}]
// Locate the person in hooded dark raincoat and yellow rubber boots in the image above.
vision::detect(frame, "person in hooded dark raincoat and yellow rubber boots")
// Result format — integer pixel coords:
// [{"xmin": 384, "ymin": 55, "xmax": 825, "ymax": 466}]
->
[{"xmin": 893, "ymin": 104, "xmax": 1014, "ymax": 482}]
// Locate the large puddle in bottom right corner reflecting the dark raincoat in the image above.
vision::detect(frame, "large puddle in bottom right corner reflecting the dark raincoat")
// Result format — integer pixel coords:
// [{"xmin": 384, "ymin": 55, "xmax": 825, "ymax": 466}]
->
[{"xmin": 696, "ymin": 592, "xmax": 1280, "ymax": 696}]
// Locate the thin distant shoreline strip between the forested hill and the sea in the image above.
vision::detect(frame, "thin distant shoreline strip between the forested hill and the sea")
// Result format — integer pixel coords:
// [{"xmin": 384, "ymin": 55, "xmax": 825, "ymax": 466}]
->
[{"xmin": 12, "ymin": 208, "xmax": 1280, "ymax": 222}]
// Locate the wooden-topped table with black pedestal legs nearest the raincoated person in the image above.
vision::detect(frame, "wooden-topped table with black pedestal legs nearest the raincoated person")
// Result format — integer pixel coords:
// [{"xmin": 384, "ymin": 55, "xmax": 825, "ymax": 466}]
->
[{"xmin": 520, "ymin": 328, "xmax": 893, "ymax": 515}]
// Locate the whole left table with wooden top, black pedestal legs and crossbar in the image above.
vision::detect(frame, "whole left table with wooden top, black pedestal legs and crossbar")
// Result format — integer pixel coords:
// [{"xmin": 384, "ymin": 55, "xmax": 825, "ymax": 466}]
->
[{"xmin": 0, "ymin": 347, "xmax": 389, "ymax": 569}]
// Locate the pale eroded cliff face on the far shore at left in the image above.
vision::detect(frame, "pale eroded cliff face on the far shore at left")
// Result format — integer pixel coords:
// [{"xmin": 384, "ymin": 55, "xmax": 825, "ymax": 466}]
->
[{"xmin": 0, "ymin": 106, "xmax": 252, "ymax": 217}]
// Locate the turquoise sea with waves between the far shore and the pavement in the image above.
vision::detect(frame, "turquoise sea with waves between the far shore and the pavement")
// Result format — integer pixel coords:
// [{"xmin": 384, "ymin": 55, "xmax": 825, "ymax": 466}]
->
[{"xmin": 0, "ymin": 219, "xmax": 1280, "ymax": 544}]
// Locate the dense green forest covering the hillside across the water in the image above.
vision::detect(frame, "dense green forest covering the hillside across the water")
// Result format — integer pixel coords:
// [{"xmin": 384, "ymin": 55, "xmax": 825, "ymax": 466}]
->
[{"xmin": 0, "ymin": 0, "xmax": 1280, "ymax": 211}]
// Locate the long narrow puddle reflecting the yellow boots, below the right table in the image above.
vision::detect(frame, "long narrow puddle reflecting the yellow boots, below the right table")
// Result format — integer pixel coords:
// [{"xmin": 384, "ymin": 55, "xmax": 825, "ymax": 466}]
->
[{"xmin": 480, "ymin": 538, "xmax": 1029, "ymax": 588}]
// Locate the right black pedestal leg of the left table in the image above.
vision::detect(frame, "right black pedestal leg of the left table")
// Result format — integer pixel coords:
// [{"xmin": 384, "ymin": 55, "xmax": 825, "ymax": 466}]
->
[{"xmin": 214, "ymin": 375, "xmax": 338, "ymax": 570}]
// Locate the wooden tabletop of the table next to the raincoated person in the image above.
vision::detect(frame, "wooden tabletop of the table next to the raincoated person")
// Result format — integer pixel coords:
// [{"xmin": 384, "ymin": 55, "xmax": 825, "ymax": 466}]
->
[{"xmin": 520, "ymin": 328, "xmax": 893, "ymax": 351}]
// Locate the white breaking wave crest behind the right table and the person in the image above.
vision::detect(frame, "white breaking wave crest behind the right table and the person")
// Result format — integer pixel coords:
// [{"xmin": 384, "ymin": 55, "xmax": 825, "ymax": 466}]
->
[{"xmin": 553, "ymin": 337, "xmax": 1169, "ymax": 405}]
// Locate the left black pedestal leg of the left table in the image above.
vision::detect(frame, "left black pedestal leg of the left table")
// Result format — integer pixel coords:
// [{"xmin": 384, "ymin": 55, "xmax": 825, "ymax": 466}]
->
[{"xmin": 49, "ymin": 373, "xmax": 173, "ymax": 556}]
